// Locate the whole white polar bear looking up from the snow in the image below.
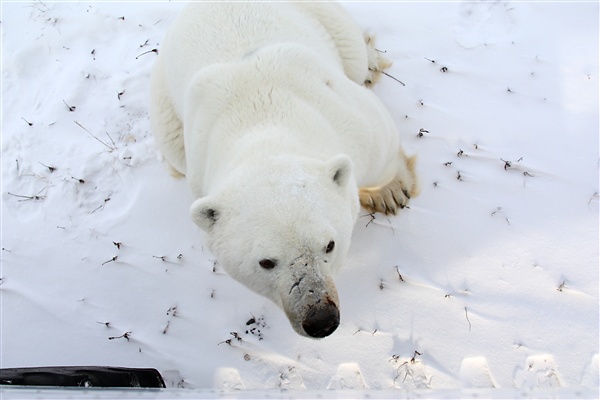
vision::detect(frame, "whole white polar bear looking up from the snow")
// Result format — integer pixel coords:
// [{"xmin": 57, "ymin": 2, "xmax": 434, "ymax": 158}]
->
[{"xmin": 150, "ymin": 1, "xmax": 417, "ymax": 338}]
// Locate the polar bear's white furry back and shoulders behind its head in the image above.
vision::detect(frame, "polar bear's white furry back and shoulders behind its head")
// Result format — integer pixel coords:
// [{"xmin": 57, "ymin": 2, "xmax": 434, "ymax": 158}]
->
[{"xmin": 157, "ymin": 2, "xmax": 408, "ymax": 197}]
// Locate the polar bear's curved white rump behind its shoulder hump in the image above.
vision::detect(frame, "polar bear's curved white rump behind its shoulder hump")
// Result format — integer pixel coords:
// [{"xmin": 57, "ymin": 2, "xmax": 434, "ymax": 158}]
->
[{"xmin": 162, "ymin": 2, "xmax": 343, "ymax": 115}]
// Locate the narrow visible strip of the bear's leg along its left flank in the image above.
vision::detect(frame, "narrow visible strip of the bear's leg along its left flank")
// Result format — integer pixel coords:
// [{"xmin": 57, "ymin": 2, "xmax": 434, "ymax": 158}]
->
[{"xmin": 150, "ymin": 56, "xmax": 185, "ymax": 178}]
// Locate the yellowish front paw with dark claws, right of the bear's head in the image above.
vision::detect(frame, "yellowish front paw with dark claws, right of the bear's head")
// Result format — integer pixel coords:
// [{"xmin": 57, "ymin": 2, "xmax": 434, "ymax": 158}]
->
[{"xmin": 358, "ymin": 154, "xmax": 419, "ymax": 215}]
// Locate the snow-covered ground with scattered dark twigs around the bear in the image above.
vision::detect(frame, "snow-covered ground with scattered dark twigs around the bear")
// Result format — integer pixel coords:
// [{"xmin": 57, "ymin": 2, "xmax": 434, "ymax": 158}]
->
[{"xmin": 0, "ymin": 1, "xmax": 600, "ymax": 397}]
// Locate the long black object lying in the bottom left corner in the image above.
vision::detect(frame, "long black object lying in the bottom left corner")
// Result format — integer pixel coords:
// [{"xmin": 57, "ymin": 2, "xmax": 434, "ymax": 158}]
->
[{"xmin": 0, "ymin": 367, "xmax": 165, "ymax": 388}]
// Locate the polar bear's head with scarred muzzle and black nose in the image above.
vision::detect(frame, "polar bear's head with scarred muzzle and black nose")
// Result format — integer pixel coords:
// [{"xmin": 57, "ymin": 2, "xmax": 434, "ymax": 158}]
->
[{"xmin": 191, "ymin": 155, "xmax": 359, "ymax": 338}]
